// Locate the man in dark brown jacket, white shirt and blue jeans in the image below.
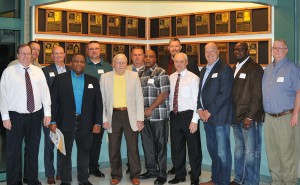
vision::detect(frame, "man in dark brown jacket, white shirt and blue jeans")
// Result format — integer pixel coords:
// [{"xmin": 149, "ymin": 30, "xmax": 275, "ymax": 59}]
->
[{"xmin": 230, "ymin": 42, "xmax": 264, "ymax": 185}]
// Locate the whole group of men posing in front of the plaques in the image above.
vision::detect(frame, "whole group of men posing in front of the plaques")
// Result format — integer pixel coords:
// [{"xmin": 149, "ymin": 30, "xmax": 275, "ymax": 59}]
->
[{"xmin": 0, "ymin": 38, "xmax": 300, "ymax": 185}]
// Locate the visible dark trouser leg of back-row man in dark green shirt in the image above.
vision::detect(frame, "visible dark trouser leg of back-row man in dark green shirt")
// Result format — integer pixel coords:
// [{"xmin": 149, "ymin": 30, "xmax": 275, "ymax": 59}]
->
[{"xmin": 89, "ymin": 129, "xmax": 104, "ymax": 171}]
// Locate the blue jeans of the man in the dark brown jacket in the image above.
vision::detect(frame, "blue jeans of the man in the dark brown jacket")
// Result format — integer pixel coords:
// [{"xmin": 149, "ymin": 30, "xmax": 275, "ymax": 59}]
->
[{"xmin": 232, "ymin": 121, "xmax": 262, "ymax": 185}]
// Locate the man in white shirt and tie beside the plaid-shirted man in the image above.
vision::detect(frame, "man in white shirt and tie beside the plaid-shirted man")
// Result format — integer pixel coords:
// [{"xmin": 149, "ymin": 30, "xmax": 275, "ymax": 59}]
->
[{"xmin": 169, "ymin": 53, "xmax": 202, "ymax": 185}]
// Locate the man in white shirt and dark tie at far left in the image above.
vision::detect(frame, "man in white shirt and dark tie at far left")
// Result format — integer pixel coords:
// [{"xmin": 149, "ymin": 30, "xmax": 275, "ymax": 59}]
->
[{"xmin": 0, "ymin": 44, "xmax": 51, "ymax": 185}]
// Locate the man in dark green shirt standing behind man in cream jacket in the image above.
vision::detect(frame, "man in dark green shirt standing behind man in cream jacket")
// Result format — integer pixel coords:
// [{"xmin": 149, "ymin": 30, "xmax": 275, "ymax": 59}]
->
[{"xmin": 84, "ymin": 41, "xmax": 112, "ymax": 177}]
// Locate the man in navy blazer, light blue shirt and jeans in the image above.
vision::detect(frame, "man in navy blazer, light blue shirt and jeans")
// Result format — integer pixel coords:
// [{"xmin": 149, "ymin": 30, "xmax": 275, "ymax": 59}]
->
[{"xmin": 197, "ymin": 42, "xmax": 233, "ymax": 185}]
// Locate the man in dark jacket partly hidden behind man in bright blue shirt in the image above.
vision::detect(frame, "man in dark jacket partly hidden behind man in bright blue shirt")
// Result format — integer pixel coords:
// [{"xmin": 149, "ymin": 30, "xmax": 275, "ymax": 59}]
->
[{"xmin": 42, "ymin": 46, "xmax": 70, "ymax": 184}]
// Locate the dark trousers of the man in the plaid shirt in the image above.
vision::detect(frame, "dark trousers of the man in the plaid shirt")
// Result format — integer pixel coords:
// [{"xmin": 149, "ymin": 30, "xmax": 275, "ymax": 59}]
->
[{"xmin": 141, "ymin": 119, "xmax": 168, "ymax": 178}]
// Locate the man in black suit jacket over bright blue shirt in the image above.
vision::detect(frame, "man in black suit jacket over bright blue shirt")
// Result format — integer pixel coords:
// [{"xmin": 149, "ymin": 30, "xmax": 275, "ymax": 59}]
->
[{"xmin": 50, "ymin": 54, "xmax": 103, "ymax": 185}]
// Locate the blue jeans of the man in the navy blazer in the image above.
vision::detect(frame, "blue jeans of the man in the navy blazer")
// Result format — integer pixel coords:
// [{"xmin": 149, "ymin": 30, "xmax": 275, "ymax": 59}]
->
[{"xmin": 204, "ymin": 123, "xmax": 232, "ymax": 185}]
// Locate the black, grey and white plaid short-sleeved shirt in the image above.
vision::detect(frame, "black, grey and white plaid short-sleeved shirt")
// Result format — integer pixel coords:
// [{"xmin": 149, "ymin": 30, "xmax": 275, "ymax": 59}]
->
[{"xmin": 139, "ymin": 64, "xmax": 170, "ymax": 121}]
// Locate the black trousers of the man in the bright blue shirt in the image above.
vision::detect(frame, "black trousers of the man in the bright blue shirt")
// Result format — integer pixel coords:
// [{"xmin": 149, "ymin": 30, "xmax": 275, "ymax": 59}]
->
[{"xmin": 58, "ymin": 121, "xmax": 93, "ymax": 183}]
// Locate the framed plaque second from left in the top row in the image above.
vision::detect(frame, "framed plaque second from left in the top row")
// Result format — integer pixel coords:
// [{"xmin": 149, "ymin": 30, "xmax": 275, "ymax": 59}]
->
[{"xmin": 68, "ymin": 12, "xmax": 82, "ymax": 33}]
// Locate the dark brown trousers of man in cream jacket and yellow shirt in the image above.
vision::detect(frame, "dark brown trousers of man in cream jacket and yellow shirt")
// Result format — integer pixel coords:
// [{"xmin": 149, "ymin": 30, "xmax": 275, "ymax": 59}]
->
[{"xmin": 108, "ymin": 111, "xmax": 141, "ymax": 180}]
